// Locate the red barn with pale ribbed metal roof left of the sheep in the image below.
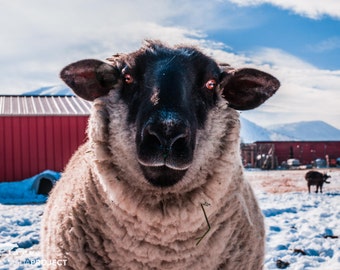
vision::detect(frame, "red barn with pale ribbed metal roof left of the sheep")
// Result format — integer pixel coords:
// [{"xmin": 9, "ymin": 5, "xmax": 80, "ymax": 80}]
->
[{"xmin": 0, "ymin": 96, "xmax": 91, "ymax": 182}]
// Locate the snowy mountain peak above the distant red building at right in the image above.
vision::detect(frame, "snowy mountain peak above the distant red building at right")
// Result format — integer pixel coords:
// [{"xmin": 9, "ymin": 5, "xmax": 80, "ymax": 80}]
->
[{"xmin": 267, "ymin": 121, "xmax": 340, "ymax": 141}]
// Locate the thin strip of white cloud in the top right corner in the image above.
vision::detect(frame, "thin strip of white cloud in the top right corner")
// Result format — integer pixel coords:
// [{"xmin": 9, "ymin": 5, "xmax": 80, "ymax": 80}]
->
[{"xmin": 229, "ymin": 0, "xmax": 340, "ymax": 19}]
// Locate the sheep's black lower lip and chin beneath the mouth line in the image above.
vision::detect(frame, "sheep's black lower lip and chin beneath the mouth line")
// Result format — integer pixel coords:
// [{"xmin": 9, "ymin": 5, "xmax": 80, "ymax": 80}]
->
[{"xmin": 141, "ymin": 165, "xmax": 187, "ymax": 187}]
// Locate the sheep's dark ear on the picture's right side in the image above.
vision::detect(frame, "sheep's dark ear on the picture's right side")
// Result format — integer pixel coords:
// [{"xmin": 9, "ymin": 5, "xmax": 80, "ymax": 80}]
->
[{"xmin": 221, "ymin": 67, "xmax": 280, "ymax": 110}]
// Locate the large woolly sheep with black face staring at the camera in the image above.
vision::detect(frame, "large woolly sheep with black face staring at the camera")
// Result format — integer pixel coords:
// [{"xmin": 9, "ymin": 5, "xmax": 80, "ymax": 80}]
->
[{"xmin": 41, "ymin": 41, "xmax": 280, "ymax": 270}]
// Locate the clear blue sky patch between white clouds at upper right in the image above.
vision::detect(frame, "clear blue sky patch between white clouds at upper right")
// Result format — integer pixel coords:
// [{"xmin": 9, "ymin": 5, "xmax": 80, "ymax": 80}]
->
[{"xmin": 208, "ymin": 3, "xmax": 340, "ymax": 70}]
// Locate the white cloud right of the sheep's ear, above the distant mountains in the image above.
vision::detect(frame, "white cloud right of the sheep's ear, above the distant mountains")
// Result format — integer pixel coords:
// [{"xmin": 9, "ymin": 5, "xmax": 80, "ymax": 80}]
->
[{"xmin": 243, "ymin": 48, "xmax": 340, "ymax": 128}]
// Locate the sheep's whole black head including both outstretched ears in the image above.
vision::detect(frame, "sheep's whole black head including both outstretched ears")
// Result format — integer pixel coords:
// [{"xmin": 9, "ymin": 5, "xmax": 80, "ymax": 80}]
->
[{"xmin": 61, "ymin": 42, "xmax": 280, "ymax": 187}]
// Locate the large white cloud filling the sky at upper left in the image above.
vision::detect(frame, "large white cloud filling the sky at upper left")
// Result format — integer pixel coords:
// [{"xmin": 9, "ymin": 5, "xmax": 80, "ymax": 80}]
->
[{"xmin": 0, "ymin": 0, "xmax": 211, "ymax": 94}]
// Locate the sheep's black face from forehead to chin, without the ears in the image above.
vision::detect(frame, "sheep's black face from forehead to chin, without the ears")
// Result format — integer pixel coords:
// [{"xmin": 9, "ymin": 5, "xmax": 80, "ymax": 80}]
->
[{"xmin": 121, "ymin": 48, "xmax": 220, "ymax": 186}]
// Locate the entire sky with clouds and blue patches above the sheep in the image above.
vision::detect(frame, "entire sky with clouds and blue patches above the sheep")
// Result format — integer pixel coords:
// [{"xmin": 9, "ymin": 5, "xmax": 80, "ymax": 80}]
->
[{"xmin": 0, "ymin": 0, "xmax": 340, "ymax": 129}]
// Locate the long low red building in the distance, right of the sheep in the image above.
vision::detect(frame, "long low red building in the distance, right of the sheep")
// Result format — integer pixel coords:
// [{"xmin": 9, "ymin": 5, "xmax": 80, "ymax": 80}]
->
[{"xmin": 241, "ymin": 141, "xmax": 340, "ymax": 169}]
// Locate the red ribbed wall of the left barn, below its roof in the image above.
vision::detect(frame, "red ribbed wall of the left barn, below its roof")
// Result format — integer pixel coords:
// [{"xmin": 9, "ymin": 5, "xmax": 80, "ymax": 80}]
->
[{"xmin": 0, "ymin": 115, "xmax": 88, "ymax": 182}]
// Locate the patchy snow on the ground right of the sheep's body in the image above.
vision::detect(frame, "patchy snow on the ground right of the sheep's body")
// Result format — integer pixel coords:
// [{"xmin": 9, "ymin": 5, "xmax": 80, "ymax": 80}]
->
[{"xmin": 258, "ymin": 192, "xmax": 340, "ymax": 270}]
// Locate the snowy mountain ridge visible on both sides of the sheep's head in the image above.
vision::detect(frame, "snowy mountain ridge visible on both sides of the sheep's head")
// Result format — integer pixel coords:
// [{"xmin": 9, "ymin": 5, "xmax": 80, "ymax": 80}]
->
[{"xmin": 23, "ymin": 85, "xmax": 340, "ymax": 143}]
